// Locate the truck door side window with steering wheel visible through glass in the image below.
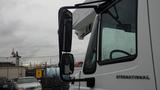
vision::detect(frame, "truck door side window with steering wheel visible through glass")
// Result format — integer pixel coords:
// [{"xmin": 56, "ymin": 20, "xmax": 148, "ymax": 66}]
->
[{"xmin": 99, "ymin": 0, "xmax": 137, "ymax": 65}]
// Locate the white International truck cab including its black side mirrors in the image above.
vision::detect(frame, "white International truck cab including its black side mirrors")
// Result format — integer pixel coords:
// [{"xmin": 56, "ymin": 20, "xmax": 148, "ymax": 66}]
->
[{"xmin": 59, "ymin": 0, "xmax": 160, "ymax": 90}]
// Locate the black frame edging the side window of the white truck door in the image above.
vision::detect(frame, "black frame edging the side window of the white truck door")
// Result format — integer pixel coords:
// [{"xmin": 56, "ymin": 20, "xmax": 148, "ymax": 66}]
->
[{"xmin": 97, "ymin": 0, "xmax": 138, "ymax": 66}]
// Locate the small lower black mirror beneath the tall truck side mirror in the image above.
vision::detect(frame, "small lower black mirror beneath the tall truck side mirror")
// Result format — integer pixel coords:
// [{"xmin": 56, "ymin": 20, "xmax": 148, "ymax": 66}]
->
[{"xmin": 59, "ymin": 53, "xmax": 74, "ymax": 75}]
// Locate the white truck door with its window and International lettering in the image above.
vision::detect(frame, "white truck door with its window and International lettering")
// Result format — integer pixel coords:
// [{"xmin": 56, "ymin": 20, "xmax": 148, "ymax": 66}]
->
[{"xmin": 77, "ymin": 0, "xmax": 156, "ymax": 90}]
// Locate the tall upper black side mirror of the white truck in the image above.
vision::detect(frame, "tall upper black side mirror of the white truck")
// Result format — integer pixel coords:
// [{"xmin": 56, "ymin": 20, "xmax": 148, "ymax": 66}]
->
[{"xmin": 58, "ymin": 8, "xmax": 72, "ymax": 52}]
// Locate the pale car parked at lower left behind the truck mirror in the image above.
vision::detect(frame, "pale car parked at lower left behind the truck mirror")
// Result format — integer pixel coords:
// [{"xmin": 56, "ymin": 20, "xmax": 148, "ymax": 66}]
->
[{"xmin": 16, "ymin": 77, "xmax": 42, "ymax": 90}]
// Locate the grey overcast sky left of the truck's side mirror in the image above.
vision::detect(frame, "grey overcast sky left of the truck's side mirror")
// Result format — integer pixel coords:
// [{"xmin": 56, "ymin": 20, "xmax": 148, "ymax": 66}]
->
[{"xmin": 0, "ymin": 0, "xmax": 84, "ymax": 57}]
